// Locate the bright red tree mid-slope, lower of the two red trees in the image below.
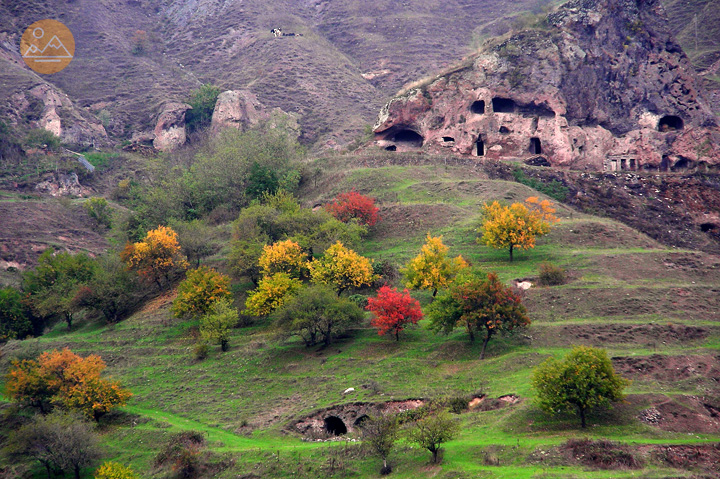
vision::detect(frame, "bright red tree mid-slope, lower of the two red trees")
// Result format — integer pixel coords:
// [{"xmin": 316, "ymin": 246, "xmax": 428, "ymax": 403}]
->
[{"xmin": 365, "ymin": 285, "xmax": 422, "ymax": 341}]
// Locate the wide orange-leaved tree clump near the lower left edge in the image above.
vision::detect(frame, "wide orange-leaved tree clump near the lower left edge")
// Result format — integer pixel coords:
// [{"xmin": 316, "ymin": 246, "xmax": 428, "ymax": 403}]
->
[{"xmin": 5, "ymin": 348, "xmax": 132, "ymax": 420}]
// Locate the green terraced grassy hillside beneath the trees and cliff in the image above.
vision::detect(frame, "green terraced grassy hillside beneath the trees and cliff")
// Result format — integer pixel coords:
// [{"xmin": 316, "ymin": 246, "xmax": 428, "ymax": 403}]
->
[{"xmin": 1, "ymin": 157, "xmax": 720, "ymax": 478}]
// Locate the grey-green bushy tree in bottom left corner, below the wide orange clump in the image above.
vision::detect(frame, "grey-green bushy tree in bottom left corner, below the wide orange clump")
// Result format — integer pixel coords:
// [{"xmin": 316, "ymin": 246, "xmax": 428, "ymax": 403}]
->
[{"xmin": 9, "ymin": 411, "xmax": 100, "ymax": 479}]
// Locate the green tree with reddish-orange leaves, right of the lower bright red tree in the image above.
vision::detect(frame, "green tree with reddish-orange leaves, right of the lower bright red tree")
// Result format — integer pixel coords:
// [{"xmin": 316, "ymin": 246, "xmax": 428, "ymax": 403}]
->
[{"xmin": 427, "ymin": 273, "xmax": 530, "ymax": 359}]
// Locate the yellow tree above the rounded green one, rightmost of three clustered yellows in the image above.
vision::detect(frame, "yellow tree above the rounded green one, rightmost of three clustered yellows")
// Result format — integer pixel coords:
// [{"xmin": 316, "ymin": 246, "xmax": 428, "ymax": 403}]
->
[{"xmin": 308, "ymin": 241, "xmax": 375, "ymax": 296}]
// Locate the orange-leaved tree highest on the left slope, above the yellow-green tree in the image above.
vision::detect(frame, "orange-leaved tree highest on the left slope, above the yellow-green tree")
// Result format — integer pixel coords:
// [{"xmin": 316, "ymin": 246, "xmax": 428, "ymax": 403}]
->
[{"xmin": 120, "ymin": 226, "xmax": 188, "ymax": 289}]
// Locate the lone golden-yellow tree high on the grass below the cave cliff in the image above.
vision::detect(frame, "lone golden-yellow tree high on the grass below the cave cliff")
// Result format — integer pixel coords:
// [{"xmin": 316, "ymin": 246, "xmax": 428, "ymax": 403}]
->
[{"xmin": 477, "ymin": 196, "xmax": 559, "ymax": 261}]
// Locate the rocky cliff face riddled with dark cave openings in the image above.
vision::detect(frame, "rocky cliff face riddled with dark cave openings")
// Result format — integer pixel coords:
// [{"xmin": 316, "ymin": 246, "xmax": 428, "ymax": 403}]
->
[{"xmin": 375, "ymin": 0, "xmax": 720, "ymax": 170}]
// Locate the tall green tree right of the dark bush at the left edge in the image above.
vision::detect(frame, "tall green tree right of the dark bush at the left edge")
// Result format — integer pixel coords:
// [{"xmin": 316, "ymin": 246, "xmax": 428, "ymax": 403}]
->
[{"xmin": 23, "ymin": 248, "xmax": 95, "ymax": 329}]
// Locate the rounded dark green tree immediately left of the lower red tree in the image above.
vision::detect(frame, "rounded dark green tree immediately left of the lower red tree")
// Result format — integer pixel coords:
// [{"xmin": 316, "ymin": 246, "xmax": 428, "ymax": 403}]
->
[{"xmin": 272, "ymin": 286, "xmax": 363, "ymax": 346}]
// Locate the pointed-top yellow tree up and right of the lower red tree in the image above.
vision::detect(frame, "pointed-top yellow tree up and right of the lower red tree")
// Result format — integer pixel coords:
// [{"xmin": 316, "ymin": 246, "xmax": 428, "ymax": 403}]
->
[{"xmin": 401, "ymin": 233, "xmax": 468, "ymax": 297}]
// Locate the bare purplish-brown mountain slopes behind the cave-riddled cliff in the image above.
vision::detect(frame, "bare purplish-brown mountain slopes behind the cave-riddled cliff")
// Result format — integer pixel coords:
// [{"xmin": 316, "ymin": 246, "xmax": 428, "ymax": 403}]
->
[{"xmin": 0, "ymin": 0, "xmax": 720, "ymax": 147}]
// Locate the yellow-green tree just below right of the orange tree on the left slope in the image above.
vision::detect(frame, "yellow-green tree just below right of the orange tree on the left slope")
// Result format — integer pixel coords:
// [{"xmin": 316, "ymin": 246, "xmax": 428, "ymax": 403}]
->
[{"xmin": 171, "ymin": 266, "xmax": 232, "ymax": 318}]
